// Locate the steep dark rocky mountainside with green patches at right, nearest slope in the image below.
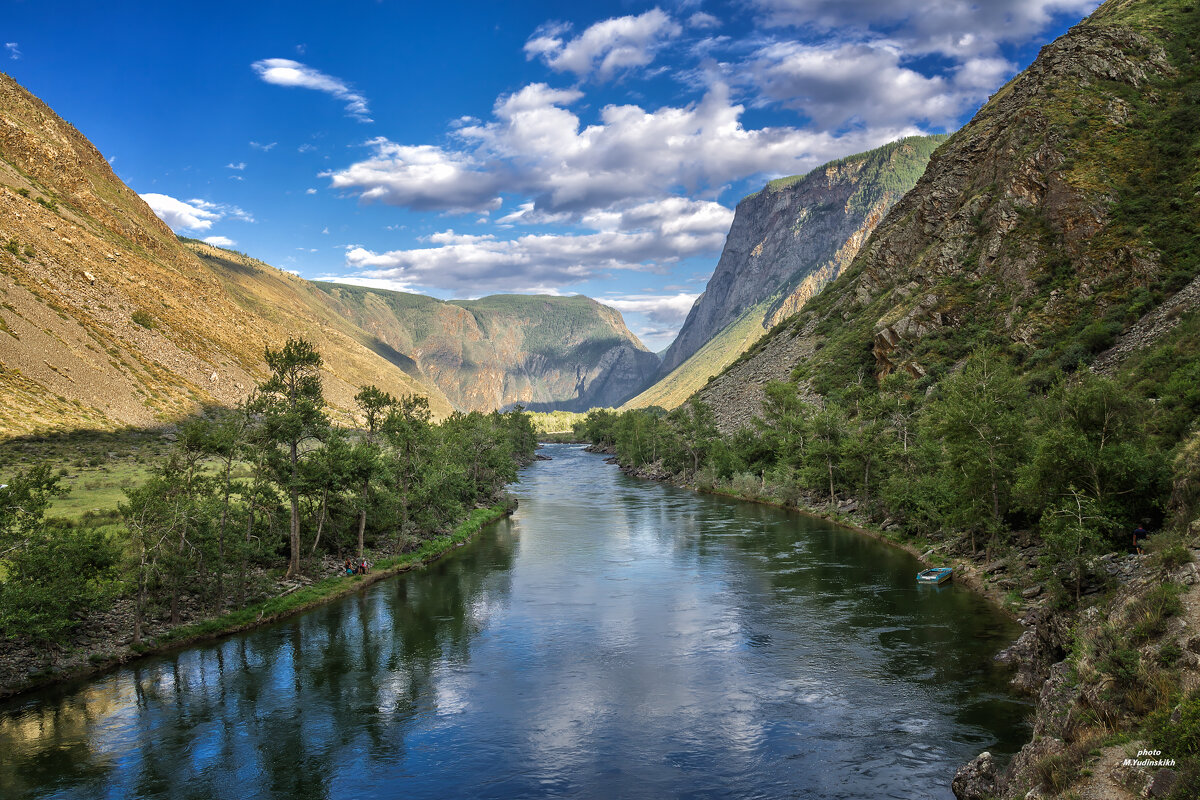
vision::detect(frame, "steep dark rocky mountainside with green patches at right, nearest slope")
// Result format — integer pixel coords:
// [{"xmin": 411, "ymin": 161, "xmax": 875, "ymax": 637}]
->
[{"xmin": 700, "ymin": 0, "xmax": 1200, "ymax": 429}]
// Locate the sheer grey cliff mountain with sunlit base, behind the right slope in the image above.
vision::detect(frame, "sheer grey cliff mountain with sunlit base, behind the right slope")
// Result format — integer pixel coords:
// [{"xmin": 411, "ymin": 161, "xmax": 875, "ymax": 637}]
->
[{"xmin": 629, "ymin": 136, "xmax": 946, "ymax": 408}]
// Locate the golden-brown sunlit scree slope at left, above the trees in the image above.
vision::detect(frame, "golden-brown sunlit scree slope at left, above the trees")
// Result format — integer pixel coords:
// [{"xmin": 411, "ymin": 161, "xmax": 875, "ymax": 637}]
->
[{"xmin": 0, "ymin": 76, "xmax": 450, "ymax": 435}]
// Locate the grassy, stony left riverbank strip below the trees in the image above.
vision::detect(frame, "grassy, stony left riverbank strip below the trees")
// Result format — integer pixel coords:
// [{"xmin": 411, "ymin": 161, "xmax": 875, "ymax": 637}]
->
[{"xmin": 0, "ymin": 498, "xmax": 516, "ymax": 698}]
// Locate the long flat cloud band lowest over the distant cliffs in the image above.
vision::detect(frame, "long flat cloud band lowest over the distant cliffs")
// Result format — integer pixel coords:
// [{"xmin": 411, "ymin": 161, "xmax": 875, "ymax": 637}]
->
[{"xmin": 333, "ymin": 198, "xmax": 733, "ymax": 295}]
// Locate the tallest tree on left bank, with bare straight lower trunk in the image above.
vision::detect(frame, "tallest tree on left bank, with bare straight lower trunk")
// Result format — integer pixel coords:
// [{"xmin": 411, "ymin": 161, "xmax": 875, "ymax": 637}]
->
[{"xmin": 257, "ymin": 338, "xmax": 329, "ymax": 578}]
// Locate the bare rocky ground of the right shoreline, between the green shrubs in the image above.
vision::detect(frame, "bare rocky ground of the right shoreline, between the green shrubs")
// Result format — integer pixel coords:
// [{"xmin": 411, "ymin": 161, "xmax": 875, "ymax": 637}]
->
[{"xmin": 586, "ymin": 445, "xmax": 1200, "ymax": 800}]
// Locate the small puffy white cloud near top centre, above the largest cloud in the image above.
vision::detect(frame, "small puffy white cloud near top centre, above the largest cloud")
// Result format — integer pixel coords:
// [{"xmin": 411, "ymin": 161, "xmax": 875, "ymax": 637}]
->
[{"xmin": 524, "ymin": 8, "xmax": 683, "ymax": 80}]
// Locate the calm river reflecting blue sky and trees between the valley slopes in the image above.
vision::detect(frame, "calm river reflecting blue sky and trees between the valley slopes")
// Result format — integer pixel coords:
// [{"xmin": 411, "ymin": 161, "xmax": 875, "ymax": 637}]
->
[{"xmin": 0, "ymin": 445, "xmax": 1030, "ymax": 800}]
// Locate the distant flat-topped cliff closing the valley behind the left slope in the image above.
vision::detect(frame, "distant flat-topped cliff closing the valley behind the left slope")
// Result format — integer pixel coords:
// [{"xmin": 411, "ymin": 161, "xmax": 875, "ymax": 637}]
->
[{"xmin": 319, "ymin": 284, "xmax": 659, "ymax": 410}]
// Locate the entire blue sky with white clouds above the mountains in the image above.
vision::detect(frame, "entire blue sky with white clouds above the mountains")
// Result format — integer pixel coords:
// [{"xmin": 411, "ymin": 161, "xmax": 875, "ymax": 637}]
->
[{"xmin": 0, "ymin": 0, "xmax": 1098, "ymax": 349}]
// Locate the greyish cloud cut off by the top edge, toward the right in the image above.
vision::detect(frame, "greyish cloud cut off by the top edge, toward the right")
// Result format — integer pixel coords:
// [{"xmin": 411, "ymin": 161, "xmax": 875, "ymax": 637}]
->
[{"xmin": 754, "ymin": 0, "xmax": 1100, "ymax": 59}]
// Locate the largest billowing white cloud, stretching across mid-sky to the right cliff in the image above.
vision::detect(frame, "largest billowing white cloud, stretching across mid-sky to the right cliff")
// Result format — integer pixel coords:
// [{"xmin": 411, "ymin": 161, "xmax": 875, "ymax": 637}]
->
[{"xmin": 325, "ymin": 83, "xmax": 919, "ymax": 215}]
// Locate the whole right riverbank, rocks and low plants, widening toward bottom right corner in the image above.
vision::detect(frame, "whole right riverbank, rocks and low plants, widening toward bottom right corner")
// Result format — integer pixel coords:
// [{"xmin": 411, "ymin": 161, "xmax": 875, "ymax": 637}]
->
[{"xmin": 589, "ymin": 446, "xmax": 1200, "ymax": 800}]
